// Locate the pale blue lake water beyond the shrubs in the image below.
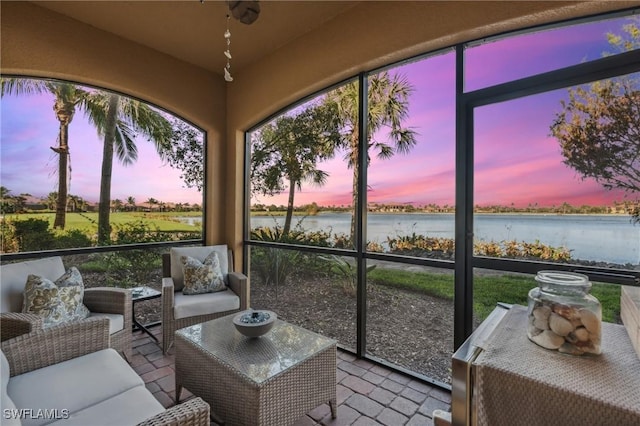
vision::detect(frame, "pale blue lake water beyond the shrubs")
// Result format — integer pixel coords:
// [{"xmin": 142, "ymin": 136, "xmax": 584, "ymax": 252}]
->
[{"xmin": 251, "ymin": 213, "xmax": 640, "ymax": 265}]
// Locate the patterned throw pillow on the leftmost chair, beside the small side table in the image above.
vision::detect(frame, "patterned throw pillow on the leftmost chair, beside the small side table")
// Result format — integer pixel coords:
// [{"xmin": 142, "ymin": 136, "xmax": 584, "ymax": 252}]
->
[{"xmin": 22, "ymin": 267, "xmax": 89, "ymax": 327}]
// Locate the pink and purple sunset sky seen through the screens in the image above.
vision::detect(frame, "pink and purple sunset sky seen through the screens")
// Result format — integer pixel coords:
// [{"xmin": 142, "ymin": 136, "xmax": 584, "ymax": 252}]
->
[{"xmin": 0, "ymin": 15, "xmax": 637, "ymax": 210}]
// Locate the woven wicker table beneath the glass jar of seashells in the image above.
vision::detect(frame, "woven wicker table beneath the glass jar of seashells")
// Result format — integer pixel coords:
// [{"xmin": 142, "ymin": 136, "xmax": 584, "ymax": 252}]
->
[{"xmin": 472, "ymin": 305, "xmax": 640, "ymax": 426}]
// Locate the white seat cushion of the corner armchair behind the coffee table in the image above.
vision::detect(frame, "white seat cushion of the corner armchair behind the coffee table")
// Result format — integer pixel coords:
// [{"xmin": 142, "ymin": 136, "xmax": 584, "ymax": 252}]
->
[{"xmin": 173, "ymin": 289, "xmax": 240, "ymax": 319}]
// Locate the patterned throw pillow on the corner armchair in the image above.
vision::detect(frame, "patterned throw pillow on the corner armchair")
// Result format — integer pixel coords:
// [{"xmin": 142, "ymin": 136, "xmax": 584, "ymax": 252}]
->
[{"xmin": 180, "ymin": 252, "xmax": 226, "ymax": 295}]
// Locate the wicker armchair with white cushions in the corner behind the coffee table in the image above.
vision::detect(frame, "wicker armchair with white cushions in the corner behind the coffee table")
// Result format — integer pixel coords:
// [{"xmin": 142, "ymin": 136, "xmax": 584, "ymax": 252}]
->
[{"xmin": 162, "ymin": 245, "xmax": 249, "ymax": 354}]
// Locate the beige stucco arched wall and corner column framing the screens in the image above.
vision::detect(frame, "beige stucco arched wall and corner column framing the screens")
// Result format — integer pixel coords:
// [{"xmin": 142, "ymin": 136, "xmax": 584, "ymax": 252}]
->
[{"xmin": 0, "ymin": 1, "xmax": 640, "ymax": 267}]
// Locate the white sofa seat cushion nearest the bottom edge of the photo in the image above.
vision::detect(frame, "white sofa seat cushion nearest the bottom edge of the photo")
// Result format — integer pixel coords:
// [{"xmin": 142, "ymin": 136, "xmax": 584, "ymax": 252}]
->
[{"xmin": 50, "ymin": 386, "xmax": 164, "ymax": 426}]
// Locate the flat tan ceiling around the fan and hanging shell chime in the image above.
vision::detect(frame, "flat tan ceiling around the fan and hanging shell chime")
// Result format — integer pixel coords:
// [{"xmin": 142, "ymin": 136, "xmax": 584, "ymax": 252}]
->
[{"xmin": 33, "ymin": 0, "xmax": 359, "ymax": 74}]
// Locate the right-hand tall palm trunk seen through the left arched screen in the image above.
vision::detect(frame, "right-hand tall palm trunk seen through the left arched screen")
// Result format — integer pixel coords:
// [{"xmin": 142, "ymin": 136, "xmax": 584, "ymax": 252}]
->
[{"xmin": 98, "ymin": 95, "xmax": 120, "ymax": 245}]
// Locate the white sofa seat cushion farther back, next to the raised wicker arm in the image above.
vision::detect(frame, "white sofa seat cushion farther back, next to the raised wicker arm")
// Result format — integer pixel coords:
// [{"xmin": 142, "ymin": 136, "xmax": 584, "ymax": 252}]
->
[{"xmin": 7, "ymin": 349, "xmax": 144, "ymax": 426}]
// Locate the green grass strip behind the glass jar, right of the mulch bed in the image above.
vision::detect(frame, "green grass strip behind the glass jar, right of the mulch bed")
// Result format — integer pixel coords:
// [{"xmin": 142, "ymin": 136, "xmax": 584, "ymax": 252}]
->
[{"xmin": 367, "ymin": 268, "xmax": 620, "ymax": 323}]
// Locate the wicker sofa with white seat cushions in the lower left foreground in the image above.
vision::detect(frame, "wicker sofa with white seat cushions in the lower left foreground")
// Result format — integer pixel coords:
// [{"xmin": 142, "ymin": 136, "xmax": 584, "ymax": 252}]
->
[{"xmin": 0, "ymin": 318, "xmax": 210, "ymax": 426}]
